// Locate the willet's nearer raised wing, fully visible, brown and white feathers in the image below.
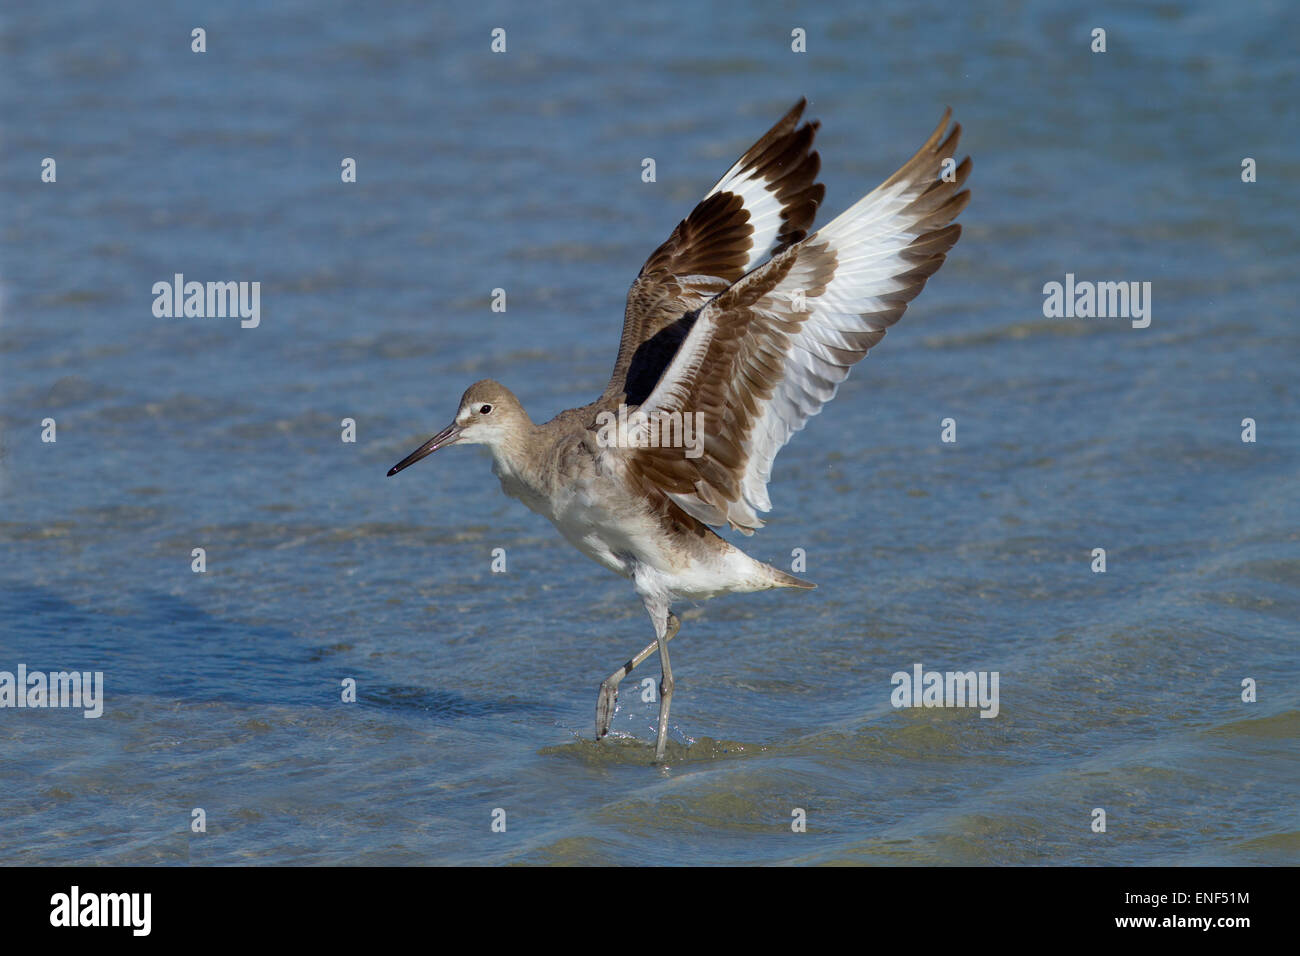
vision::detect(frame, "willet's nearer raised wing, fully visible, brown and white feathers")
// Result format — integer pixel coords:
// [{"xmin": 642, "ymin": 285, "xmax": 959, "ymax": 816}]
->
[{"xmin": 625, "ymin": 111, "xmax": 971, "ymax": 535}]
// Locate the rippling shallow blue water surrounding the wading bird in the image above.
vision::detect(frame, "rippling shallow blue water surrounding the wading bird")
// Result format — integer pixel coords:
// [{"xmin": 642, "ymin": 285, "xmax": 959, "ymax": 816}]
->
[{"xmin": 0, "ymin": 0, "xmax": 1300, "ymax": 864}]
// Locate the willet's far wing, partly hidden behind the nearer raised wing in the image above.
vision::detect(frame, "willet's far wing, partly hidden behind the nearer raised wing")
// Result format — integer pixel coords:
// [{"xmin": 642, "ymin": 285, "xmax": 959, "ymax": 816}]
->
[{"xmin": 602, "ymin": 99, "xmax": 826, "ymax": 405}]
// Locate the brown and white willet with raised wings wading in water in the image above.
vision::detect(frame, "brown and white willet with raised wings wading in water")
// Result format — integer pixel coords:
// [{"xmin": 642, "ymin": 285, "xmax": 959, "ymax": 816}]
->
[{"xmin": 389, "ymin": 100, "xmax": 971, "ymax": 760}]
